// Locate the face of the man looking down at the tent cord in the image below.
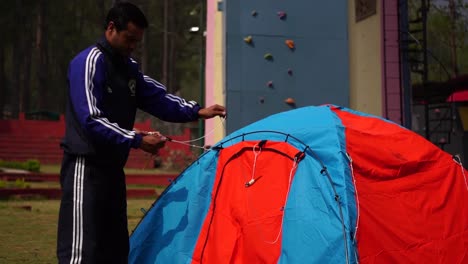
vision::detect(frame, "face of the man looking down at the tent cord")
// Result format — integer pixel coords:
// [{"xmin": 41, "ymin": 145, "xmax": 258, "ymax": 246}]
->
[{"xmin": 106, "ymin": 22, "xmax": 144, "ymax": 57}]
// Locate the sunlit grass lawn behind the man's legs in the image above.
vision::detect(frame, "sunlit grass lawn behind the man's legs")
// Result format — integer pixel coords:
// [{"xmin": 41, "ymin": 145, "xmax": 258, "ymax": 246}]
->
[{"xmin": 0, "ymin": 199, "xmax": 154, "ymax": 264}]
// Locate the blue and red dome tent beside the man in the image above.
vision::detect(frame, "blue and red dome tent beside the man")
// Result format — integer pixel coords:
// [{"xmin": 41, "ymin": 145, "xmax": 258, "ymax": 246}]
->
[{"xmin": 129, "ymin": 106, "xmax": 468, "ymax": 263}]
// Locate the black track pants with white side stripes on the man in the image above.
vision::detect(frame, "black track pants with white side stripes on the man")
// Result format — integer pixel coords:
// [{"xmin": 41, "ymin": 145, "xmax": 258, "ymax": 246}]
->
[{"xmin": 57, "ymin": 154, "xmax": 129, "ymax": 264}]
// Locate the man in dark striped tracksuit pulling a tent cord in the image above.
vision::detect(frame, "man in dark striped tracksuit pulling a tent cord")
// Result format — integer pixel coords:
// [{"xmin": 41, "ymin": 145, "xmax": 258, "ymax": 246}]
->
[{"xmin": 57, "ymin": 3, "xmax": 225, "ymax": 264}]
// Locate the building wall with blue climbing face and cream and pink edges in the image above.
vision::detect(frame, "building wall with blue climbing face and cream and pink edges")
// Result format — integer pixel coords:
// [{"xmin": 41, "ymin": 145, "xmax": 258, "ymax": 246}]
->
[{"xmin": 206, "ymin": 0, "xmax": 401, "ymax": 144}]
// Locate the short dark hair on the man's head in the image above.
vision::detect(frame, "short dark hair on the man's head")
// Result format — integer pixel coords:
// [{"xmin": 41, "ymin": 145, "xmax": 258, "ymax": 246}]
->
[{"xmin": 104, "ymin": 2, "xmax": 148, "ymax": 31}]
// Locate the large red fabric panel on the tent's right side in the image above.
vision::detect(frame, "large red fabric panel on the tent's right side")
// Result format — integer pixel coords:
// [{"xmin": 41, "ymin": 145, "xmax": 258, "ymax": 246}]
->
[{"xmin": 333, "ymin": 109, "xmax": 468, "ymax": 263}]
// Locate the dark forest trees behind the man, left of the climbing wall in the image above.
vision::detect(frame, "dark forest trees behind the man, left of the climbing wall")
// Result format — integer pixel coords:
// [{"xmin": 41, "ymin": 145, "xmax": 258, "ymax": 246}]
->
[{"xmin": 0, "ymin": 0, "xmax": 204, "ymax": 130}]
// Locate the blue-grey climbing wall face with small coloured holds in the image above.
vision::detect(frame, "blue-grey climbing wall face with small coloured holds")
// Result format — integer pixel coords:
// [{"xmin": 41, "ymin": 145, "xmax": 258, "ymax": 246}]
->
[{"xmin": 223, "ymin": 0, "xmax": 349, "ymax": 133}]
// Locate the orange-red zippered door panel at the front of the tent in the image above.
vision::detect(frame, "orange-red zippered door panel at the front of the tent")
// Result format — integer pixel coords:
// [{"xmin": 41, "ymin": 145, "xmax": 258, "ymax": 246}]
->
[{"xmin": 192, "ymin": 141, "xmax": 299, "ymax": 264}]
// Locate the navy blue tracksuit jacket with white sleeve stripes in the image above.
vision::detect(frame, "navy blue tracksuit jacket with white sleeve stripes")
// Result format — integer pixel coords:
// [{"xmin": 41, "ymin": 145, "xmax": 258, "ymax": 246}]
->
[{"xmin": 61, "ymin": 38, "xmax": 200, "ymax": 167}]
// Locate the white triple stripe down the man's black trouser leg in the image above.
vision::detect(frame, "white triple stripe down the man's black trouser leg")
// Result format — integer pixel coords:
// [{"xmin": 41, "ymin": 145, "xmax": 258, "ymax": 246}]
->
[{"xmin": 70, "ymin": 156, "xmax": 85, "ymax": 264}]
